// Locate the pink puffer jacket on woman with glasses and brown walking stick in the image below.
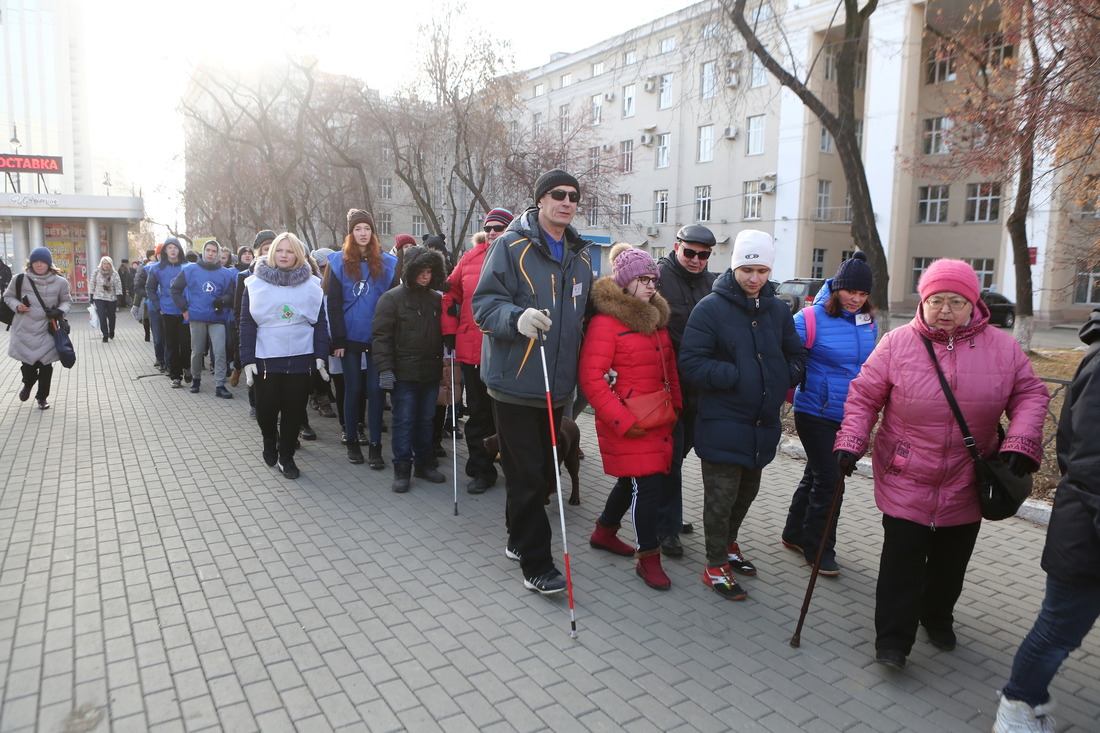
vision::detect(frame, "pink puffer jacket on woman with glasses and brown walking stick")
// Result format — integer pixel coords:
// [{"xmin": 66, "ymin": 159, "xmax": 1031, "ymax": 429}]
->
[{"xmin": 835, "ymin": 300, "xmax": 1051, "ymax": 527}]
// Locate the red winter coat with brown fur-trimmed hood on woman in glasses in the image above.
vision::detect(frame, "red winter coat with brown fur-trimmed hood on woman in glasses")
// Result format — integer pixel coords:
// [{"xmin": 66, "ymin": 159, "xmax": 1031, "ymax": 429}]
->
[{"xmin": 578, "ymin": 277, "xmax": 683, "ymax": 477}]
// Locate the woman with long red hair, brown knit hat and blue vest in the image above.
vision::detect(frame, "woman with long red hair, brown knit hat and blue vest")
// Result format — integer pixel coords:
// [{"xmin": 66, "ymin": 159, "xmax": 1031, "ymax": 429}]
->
[{"xmin": 325, "ymin": 209, "xmax": 398, "ymax": 470}]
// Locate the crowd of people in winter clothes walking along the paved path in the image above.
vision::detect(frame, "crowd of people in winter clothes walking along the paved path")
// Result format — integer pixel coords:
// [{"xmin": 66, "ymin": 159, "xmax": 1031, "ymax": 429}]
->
[{"xmin": 3, "ymin": 169, "xmax": 1100, "ymax": 732}]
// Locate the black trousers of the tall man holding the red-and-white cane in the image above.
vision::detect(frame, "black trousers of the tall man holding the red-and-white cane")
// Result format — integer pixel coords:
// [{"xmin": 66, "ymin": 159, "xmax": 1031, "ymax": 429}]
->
[{"xmin": 493, "ymin": 400, "xmax": 562, "ymax": 578}]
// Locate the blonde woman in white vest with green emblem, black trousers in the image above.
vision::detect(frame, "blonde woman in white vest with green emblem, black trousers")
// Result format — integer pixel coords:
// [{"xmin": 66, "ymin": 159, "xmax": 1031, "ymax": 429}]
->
[{"xmin": 241, "ymin": 232, "xmax": 329, "ymax": 479}]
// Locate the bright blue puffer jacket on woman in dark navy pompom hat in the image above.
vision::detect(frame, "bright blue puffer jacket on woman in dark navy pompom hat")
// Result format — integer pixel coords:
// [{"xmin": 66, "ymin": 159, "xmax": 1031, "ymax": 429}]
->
[{"xmin": 794, "ymin": 277, "xmax": 879, "ymax": 423}]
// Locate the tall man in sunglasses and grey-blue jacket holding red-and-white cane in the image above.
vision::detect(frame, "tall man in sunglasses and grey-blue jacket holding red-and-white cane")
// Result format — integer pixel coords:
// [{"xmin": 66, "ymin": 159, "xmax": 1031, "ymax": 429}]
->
[{"xmin": 473, "ymin": 169, "xmax": 592, "ymax": 595}]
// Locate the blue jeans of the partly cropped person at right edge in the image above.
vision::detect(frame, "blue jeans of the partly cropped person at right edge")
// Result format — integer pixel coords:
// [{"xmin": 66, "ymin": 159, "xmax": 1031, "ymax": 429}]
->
[{"xmin": 1003, "ymin": 576, "xmax": 1100, "ymax": 708}]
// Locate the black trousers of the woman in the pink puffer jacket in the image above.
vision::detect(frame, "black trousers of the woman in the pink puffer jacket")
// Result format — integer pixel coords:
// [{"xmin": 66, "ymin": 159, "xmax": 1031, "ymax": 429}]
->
[{"xmin": 875, "ymin": 514, "xmax": 981, "ymax": 655}]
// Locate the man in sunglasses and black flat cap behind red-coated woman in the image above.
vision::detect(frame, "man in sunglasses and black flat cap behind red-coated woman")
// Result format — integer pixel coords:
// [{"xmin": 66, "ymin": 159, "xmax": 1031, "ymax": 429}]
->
[{"xmin": 657, "ymin": 225, "xmax": 717, "ymax": 557}]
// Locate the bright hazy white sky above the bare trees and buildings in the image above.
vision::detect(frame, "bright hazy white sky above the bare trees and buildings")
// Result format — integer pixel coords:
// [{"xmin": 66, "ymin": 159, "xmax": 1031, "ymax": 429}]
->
[{"xmin": 80, "ymin": 0, "xmax": 673, "ymax": 226}]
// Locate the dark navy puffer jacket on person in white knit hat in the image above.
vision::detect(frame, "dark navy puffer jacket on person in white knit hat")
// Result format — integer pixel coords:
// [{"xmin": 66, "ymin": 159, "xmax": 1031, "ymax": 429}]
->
[{"xmin": 680, "ymin": 270, "xmax": 806, "ymax": 468}]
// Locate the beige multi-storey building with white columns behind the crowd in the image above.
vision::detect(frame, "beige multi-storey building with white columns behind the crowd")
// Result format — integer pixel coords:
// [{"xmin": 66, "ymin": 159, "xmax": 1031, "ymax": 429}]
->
[{"xmin": 517, "ymin": 0, "xmax": 1100, "ymax": 325}]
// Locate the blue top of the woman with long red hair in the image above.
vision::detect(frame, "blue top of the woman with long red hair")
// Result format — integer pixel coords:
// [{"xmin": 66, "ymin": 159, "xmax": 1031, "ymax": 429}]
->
[{"xmin": 325, "ymin": 250, "xmax": 398, "ymax": 351}]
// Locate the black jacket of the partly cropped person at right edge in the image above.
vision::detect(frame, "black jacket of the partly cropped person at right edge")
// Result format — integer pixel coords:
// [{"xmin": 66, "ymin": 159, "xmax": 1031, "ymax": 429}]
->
[{"xmin": 1043, "ymin": 308, "xmax": 1100, "ymax": 584}]
